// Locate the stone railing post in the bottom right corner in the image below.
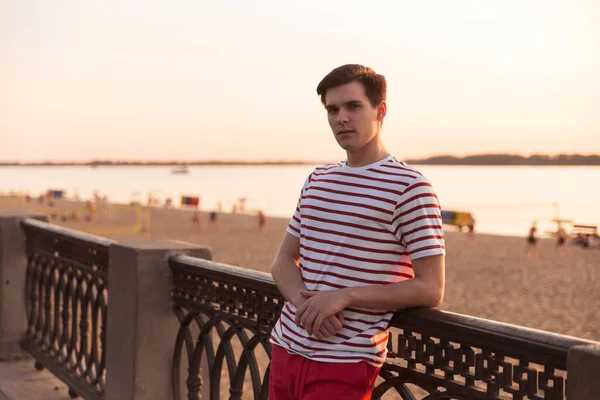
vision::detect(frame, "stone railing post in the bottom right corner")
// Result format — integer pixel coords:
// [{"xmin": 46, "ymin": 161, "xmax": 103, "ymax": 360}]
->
[{"xmin": 567, "ymin": 344, "xmax": 600, "ymax": 400}]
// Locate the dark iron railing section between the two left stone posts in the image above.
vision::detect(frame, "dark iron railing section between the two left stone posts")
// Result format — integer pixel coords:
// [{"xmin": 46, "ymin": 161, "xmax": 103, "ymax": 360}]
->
[{"xmin": 21, "ymin": 219, "xmax": 113, "ymax": 400}]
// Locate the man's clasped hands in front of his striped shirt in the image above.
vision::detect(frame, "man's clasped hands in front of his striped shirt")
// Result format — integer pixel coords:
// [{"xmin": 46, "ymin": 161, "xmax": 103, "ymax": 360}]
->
[{"xmin": 295, "ymin": 289, "xmax": 348, "ymax": 339}]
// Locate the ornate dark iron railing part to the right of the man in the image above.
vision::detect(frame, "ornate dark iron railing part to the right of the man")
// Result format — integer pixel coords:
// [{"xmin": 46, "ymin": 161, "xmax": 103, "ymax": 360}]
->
[{"xmin": 373, "ymin": 309, "xmax": 580, "ymax": 400}]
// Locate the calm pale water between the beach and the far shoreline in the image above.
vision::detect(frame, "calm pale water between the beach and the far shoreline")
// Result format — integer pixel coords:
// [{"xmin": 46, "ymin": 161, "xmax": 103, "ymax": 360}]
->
[{"xmin": 0, "ymin": 165, "xmax": 600, "ymax": 235}]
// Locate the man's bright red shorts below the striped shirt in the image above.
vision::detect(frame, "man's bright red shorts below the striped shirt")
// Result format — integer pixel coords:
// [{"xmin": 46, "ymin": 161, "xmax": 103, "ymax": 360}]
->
[{"xmin": 269, "ymin": 345, "xmax": 379, "ymax": 400}]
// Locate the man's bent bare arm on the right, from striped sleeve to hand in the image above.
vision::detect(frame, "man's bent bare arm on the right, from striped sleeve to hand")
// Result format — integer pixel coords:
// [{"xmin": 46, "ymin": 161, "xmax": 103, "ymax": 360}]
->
[{"xmin": 296, "ymin": 255, "xmax": 445, "ymax": 333}]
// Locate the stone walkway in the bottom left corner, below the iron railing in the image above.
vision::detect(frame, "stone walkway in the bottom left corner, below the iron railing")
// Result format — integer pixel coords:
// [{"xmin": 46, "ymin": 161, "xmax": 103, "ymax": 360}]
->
[{"xmin": 0, "ymin": 355, "xmax": 71, "ymax": 400}]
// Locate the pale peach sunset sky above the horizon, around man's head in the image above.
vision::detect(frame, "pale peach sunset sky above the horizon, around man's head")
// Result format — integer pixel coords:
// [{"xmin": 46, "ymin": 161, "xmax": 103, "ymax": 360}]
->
[{"xmin": 0, "ymin": 0, "xmax": 600, "ymax": 161}]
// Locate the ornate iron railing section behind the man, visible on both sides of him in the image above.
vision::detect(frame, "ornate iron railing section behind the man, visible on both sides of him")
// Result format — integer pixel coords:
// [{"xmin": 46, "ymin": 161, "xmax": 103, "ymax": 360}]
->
[{"xmin": 169, "ymin": 255, "xmax": 592, "ymax": 400}]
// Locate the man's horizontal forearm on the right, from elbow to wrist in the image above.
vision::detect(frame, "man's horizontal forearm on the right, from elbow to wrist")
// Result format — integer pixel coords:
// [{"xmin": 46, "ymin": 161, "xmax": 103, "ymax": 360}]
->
[{"xmin": 341, "ymin": 278, "xmax": 444, "ymax": 311}]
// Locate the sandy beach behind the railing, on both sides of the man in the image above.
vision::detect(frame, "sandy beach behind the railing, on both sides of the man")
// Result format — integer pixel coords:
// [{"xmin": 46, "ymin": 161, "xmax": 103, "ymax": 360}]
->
[{"xmin": 0, "ymin": 196, "xmax": 600, "ymax": 341}]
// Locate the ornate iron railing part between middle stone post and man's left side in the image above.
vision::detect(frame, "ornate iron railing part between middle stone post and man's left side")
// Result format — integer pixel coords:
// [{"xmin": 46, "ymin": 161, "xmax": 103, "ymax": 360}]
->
[{"xmin": 170, "ymin": 256, "xmax": 284, "ymax": 400}]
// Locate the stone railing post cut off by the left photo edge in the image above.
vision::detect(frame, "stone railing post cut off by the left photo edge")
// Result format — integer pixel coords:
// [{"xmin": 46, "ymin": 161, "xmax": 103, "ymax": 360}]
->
[{"xmin": 0, "ymin": 212, "xmax": 48, "ymax": 359}]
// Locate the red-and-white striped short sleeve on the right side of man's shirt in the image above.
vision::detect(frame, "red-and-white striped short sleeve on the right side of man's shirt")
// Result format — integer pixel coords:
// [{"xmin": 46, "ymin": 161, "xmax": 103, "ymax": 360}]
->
[{"xmin": 392, "ymin": 176, "xmax": 446, "ymax": 260}]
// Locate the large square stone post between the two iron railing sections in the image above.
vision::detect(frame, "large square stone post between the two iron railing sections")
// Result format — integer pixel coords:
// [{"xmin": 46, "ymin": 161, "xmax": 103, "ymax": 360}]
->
[{"xmin": 105, "ymin": 241, "xmax": 212, "ymax": 400}]
